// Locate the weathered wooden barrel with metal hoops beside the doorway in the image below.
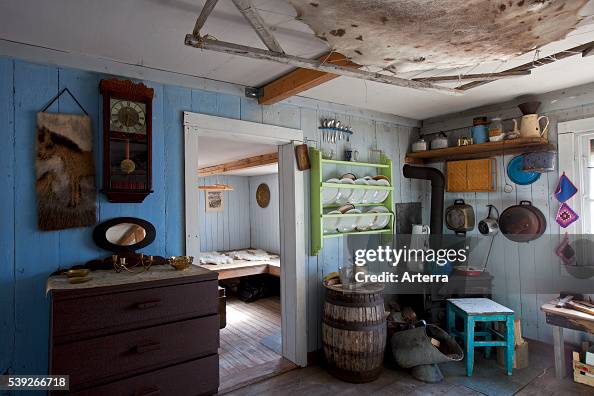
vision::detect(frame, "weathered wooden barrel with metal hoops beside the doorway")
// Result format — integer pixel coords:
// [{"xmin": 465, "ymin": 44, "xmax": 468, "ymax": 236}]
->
[{"xmin": 322, "ymin": 284, "xmax": 387, "ymax": 383}]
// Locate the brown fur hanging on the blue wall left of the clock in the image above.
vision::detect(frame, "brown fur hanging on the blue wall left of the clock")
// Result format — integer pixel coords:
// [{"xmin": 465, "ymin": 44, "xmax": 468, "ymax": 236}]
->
[{"xmin": 35, "ymin": 112, "xmax": 97, "ymax": 231}]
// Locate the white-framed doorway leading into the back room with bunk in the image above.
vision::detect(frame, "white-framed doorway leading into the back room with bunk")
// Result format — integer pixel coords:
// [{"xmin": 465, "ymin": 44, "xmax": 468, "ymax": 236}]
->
[{"xmin": 184, "ymin": 113, "xmax": 307, "ymax": 387}]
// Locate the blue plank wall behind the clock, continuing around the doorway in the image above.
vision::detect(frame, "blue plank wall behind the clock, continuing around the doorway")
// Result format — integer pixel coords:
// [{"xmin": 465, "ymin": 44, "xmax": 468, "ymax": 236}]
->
[{"xmin": 0, "ymin": 58, "xmax": 417, "ymax": 374}]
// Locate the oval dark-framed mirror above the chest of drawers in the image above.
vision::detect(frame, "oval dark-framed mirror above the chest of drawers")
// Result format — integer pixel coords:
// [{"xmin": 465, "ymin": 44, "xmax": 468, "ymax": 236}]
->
[{"xmin": 93, "ymin": 217, "xmax": 156, "ymax": 252}]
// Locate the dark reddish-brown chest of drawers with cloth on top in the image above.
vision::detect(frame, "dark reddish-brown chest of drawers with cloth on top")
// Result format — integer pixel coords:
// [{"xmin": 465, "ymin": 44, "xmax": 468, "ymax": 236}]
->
[{"xmin": 48, "ymin": 267, "xmax": 219, "ymax": 396}]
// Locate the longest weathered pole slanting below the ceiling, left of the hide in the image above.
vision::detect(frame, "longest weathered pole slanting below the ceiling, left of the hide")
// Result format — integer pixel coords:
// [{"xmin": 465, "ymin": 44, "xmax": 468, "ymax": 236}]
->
[{"xmin": 185, "ymin": 34, "xmax": 461, "ymax": 95}]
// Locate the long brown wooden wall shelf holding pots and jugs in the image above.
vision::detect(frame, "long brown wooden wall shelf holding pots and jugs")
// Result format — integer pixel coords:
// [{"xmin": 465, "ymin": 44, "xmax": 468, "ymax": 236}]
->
[{"xmin": 405, "ymin": 138, "xmax": 555, "ymax": 164}]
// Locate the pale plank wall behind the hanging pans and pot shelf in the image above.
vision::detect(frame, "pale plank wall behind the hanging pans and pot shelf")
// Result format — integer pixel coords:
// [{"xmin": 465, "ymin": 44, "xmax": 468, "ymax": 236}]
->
[{"xmin": 421, "ymin": 84, "xmax": 594, "ymax": 344}]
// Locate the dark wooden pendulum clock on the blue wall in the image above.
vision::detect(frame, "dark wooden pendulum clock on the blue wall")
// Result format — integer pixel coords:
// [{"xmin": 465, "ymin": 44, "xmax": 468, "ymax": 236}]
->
[{"xmin": 99, "ymin": 79, "xmax": 154, "ymax": 202}]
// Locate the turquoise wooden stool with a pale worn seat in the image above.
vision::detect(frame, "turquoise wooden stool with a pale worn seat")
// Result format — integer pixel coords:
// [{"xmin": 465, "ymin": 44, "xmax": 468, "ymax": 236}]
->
[{"xmin": 447, "ymin": 298, "xmax": 514, "ymax": 377}]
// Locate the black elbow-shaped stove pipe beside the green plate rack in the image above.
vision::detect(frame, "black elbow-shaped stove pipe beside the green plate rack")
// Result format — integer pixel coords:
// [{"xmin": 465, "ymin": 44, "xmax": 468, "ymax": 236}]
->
[{"xmin": 402, "ymin": 165, "xmax": 445, "ymax": 235}]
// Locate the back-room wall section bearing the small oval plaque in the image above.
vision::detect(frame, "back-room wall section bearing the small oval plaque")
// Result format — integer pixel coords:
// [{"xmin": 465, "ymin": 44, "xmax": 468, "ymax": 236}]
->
[{"xmin": 250, "ymin": 174, "xmax": 282, "ymax": 254}]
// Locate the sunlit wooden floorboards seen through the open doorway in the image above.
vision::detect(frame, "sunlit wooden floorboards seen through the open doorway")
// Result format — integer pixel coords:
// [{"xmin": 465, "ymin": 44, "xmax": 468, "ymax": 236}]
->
[{"xmin": 219, "ymin": 296, "xmax": 294, "ymax": 393}]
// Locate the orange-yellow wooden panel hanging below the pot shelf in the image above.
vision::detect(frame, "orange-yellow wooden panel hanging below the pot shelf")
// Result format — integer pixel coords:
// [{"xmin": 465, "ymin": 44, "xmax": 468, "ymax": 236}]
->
[{"xmin": 447, "ymin": 158, "xmax": 497, "ymax": 192}]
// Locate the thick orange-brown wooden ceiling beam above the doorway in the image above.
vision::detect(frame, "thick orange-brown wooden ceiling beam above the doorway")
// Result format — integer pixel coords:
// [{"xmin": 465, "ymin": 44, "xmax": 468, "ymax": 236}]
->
[{"xmin": 258, "ymin": 52, "xmax": 361, "ymax": 105}]
